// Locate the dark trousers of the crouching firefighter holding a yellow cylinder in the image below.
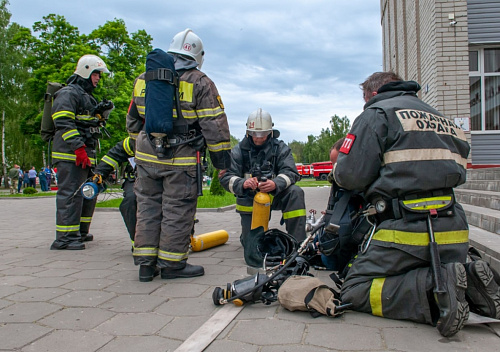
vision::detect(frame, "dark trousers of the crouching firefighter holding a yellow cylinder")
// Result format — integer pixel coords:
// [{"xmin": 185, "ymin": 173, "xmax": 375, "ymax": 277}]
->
[{"xmin": 237, "ymin": 185, "xmax": 306, "ymax": 243}]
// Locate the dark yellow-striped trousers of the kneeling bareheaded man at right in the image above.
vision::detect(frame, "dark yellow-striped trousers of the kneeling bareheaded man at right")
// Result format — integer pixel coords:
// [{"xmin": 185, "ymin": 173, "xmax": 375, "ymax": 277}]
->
[{"xmin": 341, "ymin": 204, "xmax": 469, "ymax": 325}]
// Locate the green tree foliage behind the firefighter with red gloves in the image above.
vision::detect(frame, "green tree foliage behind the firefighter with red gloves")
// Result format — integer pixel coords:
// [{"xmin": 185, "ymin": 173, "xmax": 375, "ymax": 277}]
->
[{"xmin": 0, "ymin": 6, "xmax": 153, "ymax": 173}]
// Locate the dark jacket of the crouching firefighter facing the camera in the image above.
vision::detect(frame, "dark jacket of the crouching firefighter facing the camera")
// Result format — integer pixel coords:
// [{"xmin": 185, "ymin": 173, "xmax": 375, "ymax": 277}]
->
[{"xmin": 220, "ymin": 131, "xmax": 300, "ymax": 206}]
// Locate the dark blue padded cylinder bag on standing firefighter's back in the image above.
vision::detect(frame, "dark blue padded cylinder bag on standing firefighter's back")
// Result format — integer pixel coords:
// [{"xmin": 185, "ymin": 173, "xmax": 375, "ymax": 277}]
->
[{"xmin": 145, "ymin": 49, "xmax": 179, "ymax": 136}]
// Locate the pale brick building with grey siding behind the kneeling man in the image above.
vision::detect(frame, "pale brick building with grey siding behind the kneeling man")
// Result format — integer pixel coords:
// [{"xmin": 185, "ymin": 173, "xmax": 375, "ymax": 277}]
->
[{"xmin": 380, "ymin": 0, "xmax": 500, "ymax": 167}]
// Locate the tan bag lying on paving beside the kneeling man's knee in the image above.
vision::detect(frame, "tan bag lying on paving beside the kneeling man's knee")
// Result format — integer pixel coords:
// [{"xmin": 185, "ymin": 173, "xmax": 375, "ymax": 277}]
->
[{"xmin": 278, "ymin": 275, "xmax": 343, "ymax": 318}]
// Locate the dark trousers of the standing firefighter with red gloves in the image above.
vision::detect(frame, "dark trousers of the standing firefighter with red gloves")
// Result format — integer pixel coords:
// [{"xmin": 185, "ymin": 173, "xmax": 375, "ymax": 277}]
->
[{"xmin": 56, "ymin": 162, "xmax": 97, "ymax": 243}]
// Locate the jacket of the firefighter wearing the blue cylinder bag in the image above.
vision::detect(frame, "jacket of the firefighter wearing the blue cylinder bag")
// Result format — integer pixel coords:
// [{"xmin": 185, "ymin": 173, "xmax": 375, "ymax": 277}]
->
[{"xmin": 136, "ymin": 69, "xmax": 231, "ymax": 171}]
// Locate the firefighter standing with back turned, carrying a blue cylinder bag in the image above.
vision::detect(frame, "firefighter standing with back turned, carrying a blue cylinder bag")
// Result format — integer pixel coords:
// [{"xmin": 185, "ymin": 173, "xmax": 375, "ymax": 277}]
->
[{"xmin": 134, "ymin": 29, "xmax": 231, "ymax": 282}]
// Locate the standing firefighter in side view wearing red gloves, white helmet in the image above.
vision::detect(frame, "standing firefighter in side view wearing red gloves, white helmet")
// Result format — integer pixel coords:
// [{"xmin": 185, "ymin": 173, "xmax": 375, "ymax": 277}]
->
[{"xmin": 50, "ymin": 55, "xmax": 113, "ymax": 250}]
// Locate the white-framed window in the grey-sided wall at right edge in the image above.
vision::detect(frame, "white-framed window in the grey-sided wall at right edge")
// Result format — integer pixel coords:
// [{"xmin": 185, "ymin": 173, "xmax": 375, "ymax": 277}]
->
[{"xmin": 469, "ymin": 48, "xmax": 500, "ymax": 131}]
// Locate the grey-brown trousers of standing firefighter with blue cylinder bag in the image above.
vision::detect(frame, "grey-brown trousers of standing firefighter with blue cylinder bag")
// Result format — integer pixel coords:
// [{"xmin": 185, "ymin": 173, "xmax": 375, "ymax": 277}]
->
[{"xmin": 134, "ymin": 165, "xmax": 198, "ymax": 269}]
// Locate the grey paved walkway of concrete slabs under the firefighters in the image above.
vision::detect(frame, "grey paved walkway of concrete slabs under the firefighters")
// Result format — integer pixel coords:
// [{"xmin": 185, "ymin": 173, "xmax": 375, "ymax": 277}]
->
[{"xmin": 0, "ymin": 188, "xmax": 500, "ymax": 352}]
